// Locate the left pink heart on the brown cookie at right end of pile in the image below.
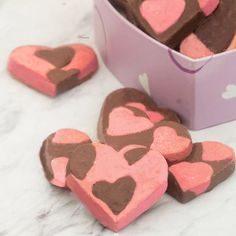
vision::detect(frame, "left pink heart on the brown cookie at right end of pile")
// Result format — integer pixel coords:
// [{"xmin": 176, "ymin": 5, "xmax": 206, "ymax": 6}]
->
[{"xmin": 169, "ymin": 162, "xmax": 213, "ymax": 195}]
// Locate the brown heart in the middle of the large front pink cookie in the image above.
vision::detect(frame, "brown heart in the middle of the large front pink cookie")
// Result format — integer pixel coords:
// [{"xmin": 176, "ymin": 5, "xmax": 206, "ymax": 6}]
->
[{"xmin": 92, "ymin": 176, "xmax": 136, "ymax": 215}]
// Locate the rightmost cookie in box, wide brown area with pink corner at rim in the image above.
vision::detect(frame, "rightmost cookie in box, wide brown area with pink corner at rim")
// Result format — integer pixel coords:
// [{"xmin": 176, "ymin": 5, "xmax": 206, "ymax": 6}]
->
[{"xmin": 180, "ymin": 0, "xmax": 236, "ymax": 59}]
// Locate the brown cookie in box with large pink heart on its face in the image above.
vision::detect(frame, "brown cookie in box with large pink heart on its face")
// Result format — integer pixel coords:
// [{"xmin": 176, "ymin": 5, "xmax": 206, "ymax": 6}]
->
[{"xmin": 132, "ymin": 0, "xmax": 219, "ymax": 48}]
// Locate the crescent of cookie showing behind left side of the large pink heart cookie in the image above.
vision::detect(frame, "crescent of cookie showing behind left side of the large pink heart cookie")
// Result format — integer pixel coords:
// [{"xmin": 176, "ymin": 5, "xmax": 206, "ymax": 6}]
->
[{"xmin": 40, "ymin": 129, "xmax": 91, "ymax": 188}]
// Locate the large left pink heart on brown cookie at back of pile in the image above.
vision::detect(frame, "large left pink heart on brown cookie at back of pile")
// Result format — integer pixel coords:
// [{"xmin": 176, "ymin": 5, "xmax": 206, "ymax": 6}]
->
[{"xmin": 107, "ymin": 107, "xmax": 153, "ymax": 136}]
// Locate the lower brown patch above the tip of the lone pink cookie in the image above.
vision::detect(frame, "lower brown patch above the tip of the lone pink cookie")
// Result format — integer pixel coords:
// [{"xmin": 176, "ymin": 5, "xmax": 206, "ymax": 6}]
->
[{"xmin": 47, "ymin": 69, "xmax": 79, "ymax": 85}]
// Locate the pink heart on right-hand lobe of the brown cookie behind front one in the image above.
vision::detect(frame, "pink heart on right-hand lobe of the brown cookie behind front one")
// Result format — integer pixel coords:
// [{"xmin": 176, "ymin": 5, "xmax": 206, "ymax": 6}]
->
[{"xmin": 151, "ymin": 126, "xmax": 192, "ymax": 162}]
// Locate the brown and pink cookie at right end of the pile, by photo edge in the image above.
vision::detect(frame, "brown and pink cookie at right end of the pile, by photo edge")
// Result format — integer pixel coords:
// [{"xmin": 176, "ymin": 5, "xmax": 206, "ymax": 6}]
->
[{"xmin": 167, "ymin": 142, "xmax": 235, "ymax": 203}]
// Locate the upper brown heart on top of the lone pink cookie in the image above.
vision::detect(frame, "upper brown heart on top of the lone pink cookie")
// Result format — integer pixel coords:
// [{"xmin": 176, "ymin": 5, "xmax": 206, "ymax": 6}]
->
[{"xmin": 35, "ymin": 47, "xmax": 75, "ymax": 68}]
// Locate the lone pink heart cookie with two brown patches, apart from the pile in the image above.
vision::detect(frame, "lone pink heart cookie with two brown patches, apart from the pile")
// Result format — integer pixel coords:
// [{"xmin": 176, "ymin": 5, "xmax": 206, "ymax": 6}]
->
[{"xmin": 8, "ymin": 44, "xmax": 98, "ymax": 96}]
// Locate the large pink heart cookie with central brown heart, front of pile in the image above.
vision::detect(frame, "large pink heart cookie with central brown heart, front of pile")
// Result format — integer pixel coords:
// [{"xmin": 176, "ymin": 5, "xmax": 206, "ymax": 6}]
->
[{"xmin": 67, "ymin": 143, "xmax": 168, "ymax": 231}]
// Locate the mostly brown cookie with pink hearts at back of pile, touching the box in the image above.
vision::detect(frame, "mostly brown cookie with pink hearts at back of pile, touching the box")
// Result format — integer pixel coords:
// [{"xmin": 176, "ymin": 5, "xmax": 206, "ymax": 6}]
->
[{"xmin": 98, "ymin": 89, "xmax": 192, "ymax": 162}]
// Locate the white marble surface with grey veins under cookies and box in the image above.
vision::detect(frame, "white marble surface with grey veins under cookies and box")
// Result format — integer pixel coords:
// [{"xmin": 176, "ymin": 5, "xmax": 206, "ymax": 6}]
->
[{"xmin": 0, "ymin": 0, "xmax": 236, "ymax": 236}]
